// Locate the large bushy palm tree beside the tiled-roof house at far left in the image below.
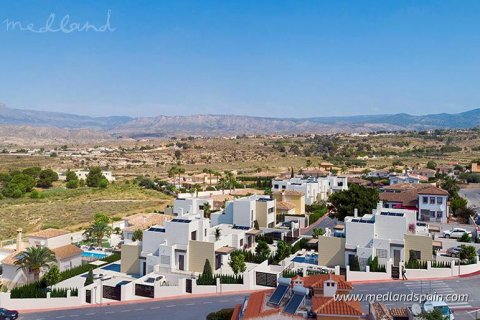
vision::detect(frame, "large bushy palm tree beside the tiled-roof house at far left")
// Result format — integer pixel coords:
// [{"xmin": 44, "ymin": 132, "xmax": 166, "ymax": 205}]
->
[{"xmin": 15, "ymin": 247, "xmax": 57, "ymax": 281}]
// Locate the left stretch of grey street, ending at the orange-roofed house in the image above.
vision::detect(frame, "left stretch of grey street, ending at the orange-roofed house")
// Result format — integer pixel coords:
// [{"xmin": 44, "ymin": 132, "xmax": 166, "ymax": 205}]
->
[{"xmin": 20, "ymin": 295, "xmax": 245, "ymax": 320}]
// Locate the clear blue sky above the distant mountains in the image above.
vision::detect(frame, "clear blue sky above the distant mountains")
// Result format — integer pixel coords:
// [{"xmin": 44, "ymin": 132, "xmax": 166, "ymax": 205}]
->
[{"xmin": 0, "ymin": 0, "xmax": 480, "ymax": 117}]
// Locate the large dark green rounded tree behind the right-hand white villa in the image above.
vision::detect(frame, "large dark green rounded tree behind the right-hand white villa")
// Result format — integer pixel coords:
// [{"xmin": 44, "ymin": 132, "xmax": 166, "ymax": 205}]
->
[{"xmin": 329, "ymin": 184, "xmax": 378, "ymax": 220}]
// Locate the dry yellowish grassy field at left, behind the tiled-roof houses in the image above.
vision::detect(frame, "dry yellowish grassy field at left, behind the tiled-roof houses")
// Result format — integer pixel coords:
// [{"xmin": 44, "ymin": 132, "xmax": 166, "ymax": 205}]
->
[{"xmin": 0, "ymin": 184, "xmax": 170, "ymax": 239}]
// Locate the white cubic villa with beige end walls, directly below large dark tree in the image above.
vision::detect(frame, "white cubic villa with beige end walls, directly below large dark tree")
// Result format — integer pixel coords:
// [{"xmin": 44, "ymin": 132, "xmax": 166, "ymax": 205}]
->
[{"xmin": 318, "ymin": 202, "xmax": 432, "ymax": 270}]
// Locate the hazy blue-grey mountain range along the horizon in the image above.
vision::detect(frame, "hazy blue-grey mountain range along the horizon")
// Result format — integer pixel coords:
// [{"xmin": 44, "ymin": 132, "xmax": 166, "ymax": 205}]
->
[{"xmin": 0, "ymin": 104, "xmax": 480, "ymax": 139}]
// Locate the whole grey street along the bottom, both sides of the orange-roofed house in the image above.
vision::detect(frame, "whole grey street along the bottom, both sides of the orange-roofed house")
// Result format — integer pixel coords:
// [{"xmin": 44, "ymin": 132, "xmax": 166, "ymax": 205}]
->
[{"xmin": 21, "ymin": 274, "xmax": 480, "ymax": 320}]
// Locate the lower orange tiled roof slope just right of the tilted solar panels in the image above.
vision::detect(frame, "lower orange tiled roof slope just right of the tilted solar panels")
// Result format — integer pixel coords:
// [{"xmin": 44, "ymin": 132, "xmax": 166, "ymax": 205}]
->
[{"xmin": 312, "ymin": 296, "xmax": 362, "ymax": 316}]
